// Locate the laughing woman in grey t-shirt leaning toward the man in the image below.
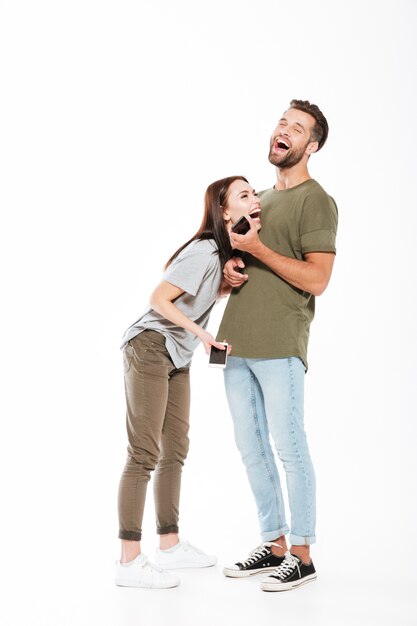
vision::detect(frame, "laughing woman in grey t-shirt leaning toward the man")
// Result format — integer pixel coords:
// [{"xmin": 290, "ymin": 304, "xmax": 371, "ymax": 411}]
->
[{"xmin": 116, "ymin": 176, "xmax": 260, "ymax": 588}]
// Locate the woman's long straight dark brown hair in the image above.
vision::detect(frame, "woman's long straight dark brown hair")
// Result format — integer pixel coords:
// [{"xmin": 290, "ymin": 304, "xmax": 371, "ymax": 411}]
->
[{"xmin": 164, "ymin": 176, "xmax": 248, "ymax": 269}]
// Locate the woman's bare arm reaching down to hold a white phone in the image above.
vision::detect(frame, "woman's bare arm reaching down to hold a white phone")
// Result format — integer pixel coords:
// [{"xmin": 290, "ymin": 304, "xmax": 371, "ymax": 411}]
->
[{"xmin": 150, "ymin": 280, "xmax": 228, "ymax": 354}]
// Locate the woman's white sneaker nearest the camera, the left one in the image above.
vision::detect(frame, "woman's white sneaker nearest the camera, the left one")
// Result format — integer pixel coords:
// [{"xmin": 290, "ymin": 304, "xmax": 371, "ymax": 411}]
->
[{"xmin": 115, "ymin": 554, "xmax": 180, "ymax": 589}]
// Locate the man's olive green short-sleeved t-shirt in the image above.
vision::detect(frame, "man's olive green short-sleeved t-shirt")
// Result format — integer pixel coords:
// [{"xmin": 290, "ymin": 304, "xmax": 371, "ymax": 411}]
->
[{"xmin": 217, "ymin": 180, "xmax": 337, "ymax": 368}]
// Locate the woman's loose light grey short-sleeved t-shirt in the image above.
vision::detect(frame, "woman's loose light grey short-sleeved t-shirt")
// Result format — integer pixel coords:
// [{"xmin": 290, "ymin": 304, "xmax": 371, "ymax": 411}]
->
[{"xmin": 121, "ymin": 239, "xmax": 222, "ymax": 368}]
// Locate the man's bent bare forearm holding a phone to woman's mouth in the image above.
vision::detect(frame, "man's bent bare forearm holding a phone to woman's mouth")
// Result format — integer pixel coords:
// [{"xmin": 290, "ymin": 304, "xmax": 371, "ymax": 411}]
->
[{"xmin": 229, "ymin": 224, "xmax": 335, "ymax": 296}]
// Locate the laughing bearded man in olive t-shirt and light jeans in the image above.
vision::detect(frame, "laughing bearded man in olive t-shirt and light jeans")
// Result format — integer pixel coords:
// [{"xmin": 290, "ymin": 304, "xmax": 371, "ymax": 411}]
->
[{"xmin": 218, "ymin": 100, "xmax": 337, "ymax": 591}]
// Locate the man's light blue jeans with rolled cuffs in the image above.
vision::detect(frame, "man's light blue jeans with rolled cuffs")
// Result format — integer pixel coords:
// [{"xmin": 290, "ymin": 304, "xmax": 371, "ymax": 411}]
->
[{"xmin": 224, "ymin": 357, "xmax": 316, "ymax": 545}]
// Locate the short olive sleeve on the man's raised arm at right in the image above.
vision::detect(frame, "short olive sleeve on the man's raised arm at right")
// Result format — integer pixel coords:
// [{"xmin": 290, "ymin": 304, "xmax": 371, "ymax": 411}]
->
[{"xmin": 300, "ymin": 192, "xmax": 338, "ymax": 254}]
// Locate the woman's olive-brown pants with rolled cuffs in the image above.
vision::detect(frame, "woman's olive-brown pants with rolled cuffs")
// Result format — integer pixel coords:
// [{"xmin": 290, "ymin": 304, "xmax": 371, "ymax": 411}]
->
[{"xmin": 118, "ymin": 330, "xmax": 190, "ymax": 541}]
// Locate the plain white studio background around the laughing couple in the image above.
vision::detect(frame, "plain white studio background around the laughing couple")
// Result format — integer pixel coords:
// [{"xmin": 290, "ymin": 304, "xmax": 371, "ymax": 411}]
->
[{"xmin": 0, "ymin": 0, "xmax": 417, "ymax": 626}]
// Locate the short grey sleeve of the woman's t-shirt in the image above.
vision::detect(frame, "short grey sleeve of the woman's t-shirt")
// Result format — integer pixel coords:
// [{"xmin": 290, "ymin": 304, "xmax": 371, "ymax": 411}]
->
[{"xmin": 162, "ymin": 240, "xmax": 218, "ymax": 296}]
